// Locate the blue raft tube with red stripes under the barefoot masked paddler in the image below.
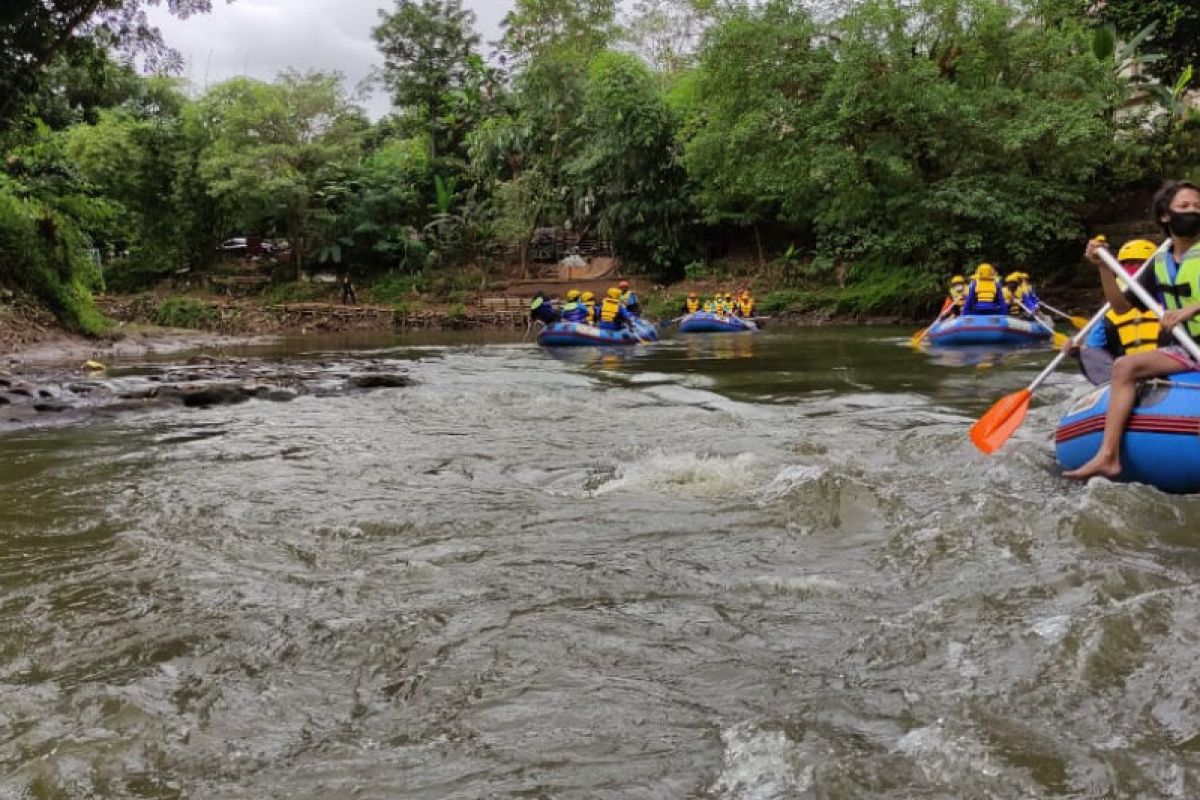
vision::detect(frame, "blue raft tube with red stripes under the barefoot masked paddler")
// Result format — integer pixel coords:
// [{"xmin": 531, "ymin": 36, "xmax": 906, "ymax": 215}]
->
[{"xmin": 1055, "ymin": 372, "xmax": 1200, "ymax": 494}]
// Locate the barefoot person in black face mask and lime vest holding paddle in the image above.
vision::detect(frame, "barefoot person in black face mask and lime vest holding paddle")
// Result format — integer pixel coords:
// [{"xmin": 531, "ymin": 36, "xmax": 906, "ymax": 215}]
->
[{"xmin": 1063, "ymin": 181, "xmax": 1200, "ymax": 479}]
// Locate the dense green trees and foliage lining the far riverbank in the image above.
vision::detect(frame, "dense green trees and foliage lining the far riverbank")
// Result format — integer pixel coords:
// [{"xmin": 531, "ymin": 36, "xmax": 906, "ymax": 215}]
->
[{"xmin": 0, "ymin": 0, "xmax": 1200, "ymax": 331}]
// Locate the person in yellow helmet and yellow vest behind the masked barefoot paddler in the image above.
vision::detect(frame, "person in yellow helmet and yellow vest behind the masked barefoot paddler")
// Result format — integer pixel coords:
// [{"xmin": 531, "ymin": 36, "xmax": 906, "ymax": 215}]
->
[{"xmin": 1066, "ymin": 239, "xmax": 1160, "ymax": 386}]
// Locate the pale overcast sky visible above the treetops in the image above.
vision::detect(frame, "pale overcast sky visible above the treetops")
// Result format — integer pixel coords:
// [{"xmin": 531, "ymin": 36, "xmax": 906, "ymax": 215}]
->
[{"xmin": 150, "ymin": 0, "xmax": 512, "ymax": 118}]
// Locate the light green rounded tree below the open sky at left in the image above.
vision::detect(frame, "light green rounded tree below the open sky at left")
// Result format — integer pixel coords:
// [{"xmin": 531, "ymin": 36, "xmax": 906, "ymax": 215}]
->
[{"xmin": 186, "ymin": 72, "xmax": 367, "ymax": 277}]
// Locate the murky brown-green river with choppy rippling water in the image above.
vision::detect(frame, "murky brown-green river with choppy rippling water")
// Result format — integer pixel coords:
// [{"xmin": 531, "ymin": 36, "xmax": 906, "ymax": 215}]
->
[{"xmin": 0, "ymin": 327, "xmax": 1200, "ymax": 800}]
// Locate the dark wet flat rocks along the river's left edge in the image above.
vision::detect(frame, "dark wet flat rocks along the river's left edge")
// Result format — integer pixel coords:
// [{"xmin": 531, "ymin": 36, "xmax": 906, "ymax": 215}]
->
[{"xmin": 0, "ymin": 355, "xmax": 413, "ymax": 431}]
